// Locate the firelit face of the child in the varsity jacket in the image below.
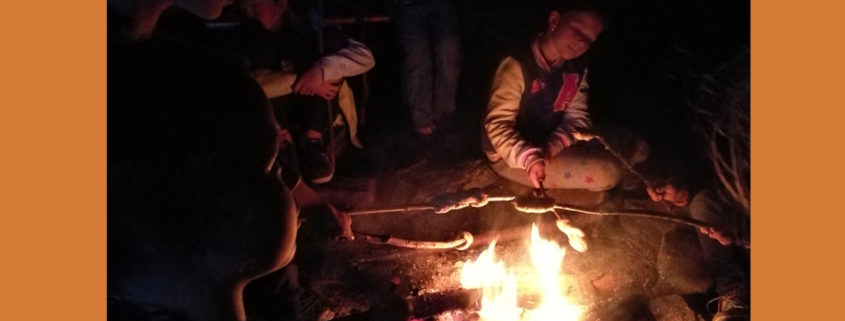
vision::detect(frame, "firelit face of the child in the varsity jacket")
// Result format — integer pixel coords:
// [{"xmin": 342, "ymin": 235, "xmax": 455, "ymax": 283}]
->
[{"xmin": 548, "ymin": 11, "xmax": 604, "ymax": 60}]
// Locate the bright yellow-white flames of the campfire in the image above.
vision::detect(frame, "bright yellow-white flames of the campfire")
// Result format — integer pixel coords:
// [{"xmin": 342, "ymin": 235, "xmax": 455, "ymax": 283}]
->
[{"xmin": 461, "ymin": 225, "xmax": 582, "ymax": 321}]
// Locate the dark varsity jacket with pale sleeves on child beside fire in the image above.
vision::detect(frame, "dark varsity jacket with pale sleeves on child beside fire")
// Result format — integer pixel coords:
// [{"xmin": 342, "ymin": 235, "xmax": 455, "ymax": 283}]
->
[{"xmin": 482, "ymin": 40, "xmax": 592, "ymax": 169}]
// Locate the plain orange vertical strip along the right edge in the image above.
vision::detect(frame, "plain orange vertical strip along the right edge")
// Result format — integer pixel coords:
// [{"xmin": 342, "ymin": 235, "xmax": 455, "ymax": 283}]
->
[{"xmin": 751, "ymin": 0, "xmax": 845, "ymax": 320}]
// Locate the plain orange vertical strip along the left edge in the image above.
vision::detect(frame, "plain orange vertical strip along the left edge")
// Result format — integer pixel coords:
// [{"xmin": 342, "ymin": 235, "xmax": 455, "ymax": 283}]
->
[{"xmin": 0, "ymin": 1, "xmax": 106, "ymax": 320}]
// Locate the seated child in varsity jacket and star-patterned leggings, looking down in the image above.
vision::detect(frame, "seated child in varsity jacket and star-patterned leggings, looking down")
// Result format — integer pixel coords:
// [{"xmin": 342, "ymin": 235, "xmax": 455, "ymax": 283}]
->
[{"xmin": 482, "ymin": 5, "xmax": 646, "ymax": 191}]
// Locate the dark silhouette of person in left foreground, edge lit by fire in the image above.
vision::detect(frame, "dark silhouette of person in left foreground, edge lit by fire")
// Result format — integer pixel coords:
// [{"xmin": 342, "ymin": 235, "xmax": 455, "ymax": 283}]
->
[{"xmin": 108, "ymin": 42, "xmax": 296, "ymax": 320}]
